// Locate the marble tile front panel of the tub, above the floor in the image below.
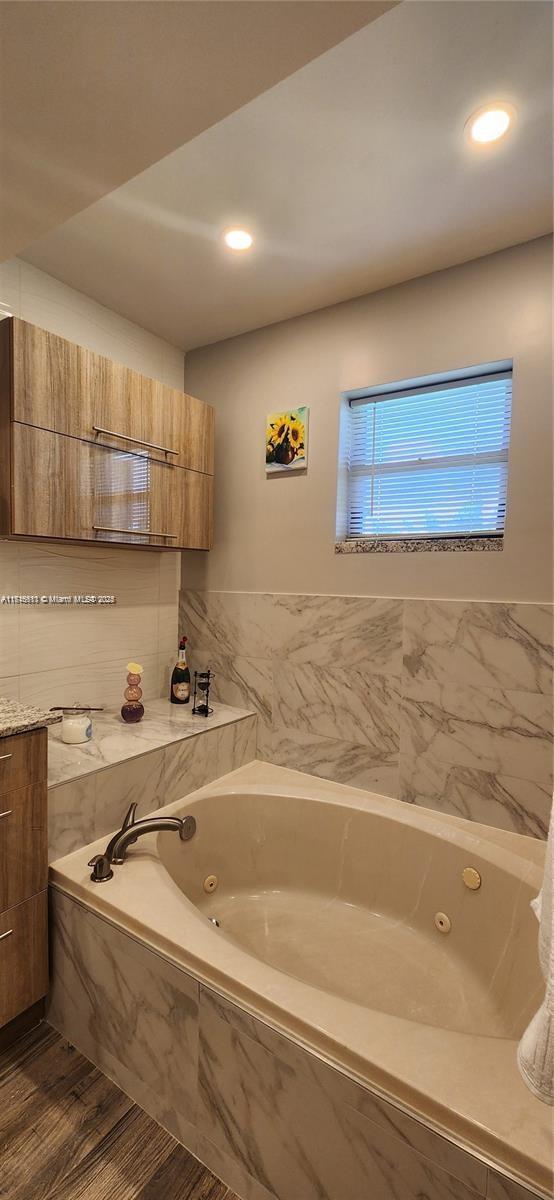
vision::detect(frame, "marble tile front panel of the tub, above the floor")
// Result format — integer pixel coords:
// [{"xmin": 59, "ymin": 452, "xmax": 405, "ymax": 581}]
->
[{"xmin": 48, "ymin": 890, "xmax": 544, "ymax": 1200}]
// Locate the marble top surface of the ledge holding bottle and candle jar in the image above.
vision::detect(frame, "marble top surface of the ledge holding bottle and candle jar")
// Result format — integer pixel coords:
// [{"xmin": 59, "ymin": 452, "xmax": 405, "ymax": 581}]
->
[{"xmin": 48, "ymin": 700, "xmax": 255, "ymax": 787}]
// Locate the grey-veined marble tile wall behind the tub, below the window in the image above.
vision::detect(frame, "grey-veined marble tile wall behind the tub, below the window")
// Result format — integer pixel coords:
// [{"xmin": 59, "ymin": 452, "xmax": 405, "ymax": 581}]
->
[{"xmin": 180, "ymin": 592, "xmax": 553, "ymax": 838}]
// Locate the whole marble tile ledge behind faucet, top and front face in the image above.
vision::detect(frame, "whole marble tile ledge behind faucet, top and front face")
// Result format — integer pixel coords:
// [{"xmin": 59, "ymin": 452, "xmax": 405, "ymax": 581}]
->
[{"xmin": 48, "ymin": 701, "xmax": 257, "ymax": 862}]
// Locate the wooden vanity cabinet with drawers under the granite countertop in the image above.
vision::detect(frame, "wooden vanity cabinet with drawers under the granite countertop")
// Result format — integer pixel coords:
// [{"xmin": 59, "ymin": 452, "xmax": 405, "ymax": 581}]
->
[{"xmin": 0, "ymin": 730, "xmax": 48, "ymax": 1028}]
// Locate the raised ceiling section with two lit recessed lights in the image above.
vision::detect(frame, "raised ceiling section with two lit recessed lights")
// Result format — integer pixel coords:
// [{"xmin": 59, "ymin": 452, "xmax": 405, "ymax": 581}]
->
[{"xmin": 19, "ymin": 0, "xmax": 553, "ymax": 349}]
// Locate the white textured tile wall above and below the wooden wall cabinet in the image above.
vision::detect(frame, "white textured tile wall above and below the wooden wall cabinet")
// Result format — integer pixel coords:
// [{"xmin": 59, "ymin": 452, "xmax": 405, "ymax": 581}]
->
[{"xmin": 0, "ymin": 259, "xmax": 183, "ymax": 707}]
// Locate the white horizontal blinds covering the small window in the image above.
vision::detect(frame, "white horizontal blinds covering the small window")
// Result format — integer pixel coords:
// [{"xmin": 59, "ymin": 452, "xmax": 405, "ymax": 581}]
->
[{"xmin": 347, "ymin": 371, "xmax": 512, "ymax": 538}]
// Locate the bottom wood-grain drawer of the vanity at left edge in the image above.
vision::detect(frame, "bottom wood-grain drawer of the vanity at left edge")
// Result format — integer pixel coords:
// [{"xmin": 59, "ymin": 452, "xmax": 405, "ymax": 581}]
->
[{"xmin": 0, "ymin": 892, "xmax": 48, "ymax": 1026}]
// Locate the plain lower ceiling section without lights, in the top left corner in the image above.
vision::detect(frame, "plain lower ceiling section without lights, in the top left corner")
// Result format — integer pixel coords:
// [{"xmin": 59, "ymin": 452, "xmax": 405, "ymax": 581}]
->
[{"xmin": 0, "ymin": 0, "xmax": 396, "ymax": 258}]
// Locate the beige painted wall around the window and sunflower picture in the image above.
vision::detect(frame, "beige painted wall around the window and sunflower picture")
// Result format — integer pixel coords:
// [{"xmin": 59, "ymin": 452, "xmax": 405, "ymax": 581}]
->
[{"xmin": 183, "ymin": 238, "xmax": 552, "ymax": 601}]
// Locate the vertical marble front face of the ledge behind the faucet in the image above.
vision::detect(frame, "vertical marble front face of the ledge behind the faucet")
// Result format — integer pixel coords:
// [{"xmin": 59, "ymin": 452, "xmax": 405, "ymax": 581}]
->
[{"xmin": 48, "ymin": 716, "xmax": 257, "ymax": 862}]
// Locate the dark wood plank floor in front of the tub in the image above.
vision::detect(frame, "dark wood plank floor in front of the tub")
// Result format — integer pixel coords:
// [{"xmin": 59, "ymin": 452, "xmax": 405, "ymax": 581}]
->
[{"xmin": 0, "ymin": 1024, "xmax": 237, "ymax": 1200}]
